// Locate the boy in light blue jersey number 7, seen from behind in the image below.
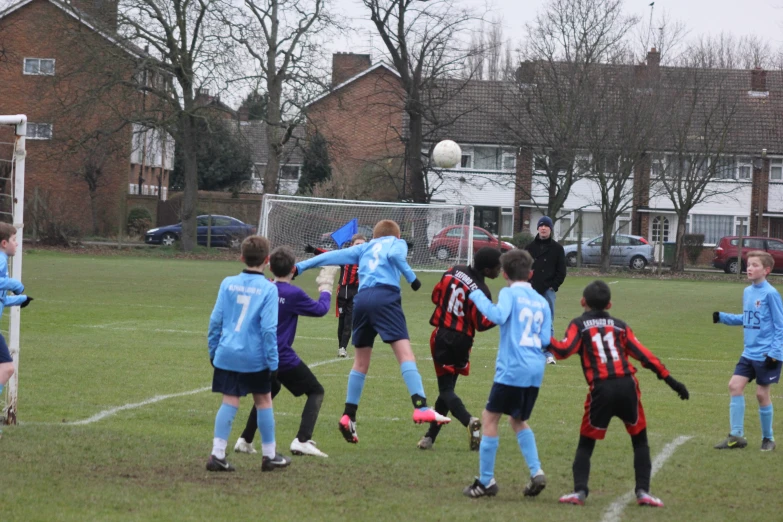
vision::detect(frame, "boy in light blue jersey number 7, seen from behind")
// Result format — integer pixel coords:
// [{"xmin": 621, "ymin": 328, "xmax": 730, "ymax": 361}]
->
[{"xmin": 207, "ymin": 236, "xmax": 291, "ymax": 471}]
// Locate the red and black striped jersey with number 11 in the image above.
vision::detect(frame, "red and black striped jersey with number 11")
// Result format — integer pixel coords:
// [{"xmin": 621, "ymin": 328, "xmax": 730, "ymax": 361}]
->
[{"xmin": 549, "ymin": 310, "xmax": 669, "ymax": 386}]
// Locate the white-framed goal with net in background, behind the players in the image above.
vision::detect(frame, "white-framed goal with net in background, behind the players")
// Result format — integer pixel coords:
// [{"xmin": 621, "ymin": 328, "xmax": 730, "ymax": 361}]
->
[{"xmin": 258, "ymin": 194, "xmax": 473, "ymax": 271}]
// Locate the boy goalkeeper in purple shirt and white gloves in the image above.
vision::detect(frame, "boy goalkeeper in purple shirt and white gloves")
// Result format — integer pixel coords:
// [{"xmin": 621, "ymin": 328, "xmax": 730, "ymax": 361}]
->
[{"xmin": 234, "ymin": 246, "xmax": 337, "ymax": 457}]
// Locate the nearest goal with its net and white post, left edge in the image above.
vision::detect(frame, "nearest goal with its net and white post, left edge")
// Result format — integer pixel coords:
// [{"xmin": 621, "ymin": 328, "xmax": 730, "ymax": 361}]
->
[{"xmin": 0, "ymin": 115, "xmax": 27, "ymax": 424}]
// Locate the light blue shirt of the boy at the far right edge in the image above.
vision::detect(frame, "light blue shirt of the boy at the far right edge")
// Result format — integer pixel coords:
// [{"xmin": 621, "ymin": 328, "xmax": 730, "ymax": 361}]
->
[{"xmin": 720, "ymin": 280, "xmax": 783, "ymax": 361}]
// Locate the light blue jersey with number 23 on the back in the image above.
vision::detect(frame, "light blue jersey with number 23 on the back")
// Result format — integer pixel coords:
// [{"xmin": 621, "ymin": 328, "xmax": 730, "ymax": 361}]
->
[{"xmin": 470, "ymin": 281, "xmax": 552, "ymax": 388}]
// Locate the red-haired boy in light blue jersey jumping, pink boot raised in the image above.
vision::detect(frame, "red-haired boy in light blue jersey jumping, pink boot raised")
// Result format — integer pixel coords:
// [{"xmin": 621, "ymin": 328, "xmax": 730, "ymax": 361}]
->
[{"xmin": 296, "ymin": 220, "xmax": 451, "ymax": 444}]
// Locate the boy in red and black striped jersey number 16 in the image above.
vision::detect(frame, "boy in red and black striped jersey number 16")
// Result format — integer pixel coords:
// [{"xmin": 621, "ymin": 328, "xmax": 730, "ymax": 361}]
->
[{"xmin": 417, "ymin": 247, "xmax": 500, "ymax": 451}]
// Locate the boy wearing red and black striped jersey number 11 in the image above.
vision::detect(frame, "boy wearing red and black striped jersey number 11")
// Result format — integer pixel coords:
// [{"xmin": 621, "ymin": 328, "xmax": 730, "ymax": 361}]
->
[{"xmin": 549, "ymin": 281, "xmax": 690, "ymax": 507}]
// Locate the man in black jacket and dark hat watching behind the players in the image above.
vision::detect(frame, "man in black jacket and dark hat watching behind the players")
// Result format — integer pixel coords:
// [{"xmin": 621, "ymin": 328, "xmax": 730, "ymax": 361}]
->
[{"xmin": 525, "ymin": 216, "xmax": 566, "ymax": 364}]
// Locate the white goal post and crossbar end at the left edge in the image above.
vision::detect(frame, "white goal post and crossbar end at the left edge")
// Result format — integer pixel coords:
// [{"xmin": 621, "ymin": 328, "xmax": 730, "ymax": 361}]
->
[{"xmin": 0, "ymin": 114, "xmax": 27, "ymax": 424}]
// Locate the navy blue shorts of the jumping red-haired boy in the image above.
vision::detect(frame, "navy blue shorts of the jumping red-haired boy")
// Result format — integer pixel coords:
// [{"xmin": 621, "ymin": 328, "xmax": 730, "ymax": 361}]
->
[{"xmin": 353, "ymin": 285, "xmax": 410, "ymax": 348}]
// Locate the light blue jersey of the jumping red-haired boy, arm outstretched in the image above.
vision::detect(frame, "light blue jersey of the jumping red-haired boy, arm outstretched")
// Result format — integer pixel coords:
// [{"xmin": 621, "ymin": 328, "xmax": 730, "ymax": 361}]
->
[{"xmin": 296, "ymin": 236, "xmax": 416, "ymax": 291}]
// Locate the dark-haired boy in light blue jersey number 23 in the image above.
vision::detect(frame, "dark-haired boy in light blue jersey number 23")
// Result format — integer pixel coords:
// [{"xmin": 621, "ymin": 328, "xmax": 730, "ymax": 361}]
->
[{"xmin": 463, "ymin": 250, "xmax": 552, "ymax": 498}]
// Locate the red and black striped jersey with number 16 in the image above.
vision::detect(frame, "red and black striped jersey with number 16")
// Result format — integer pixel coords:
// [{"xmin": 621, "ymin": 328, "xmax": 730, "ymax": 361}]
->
[{"xmin": 430, "ymin": 266, "xmax": 495, "ymax": 337}]
